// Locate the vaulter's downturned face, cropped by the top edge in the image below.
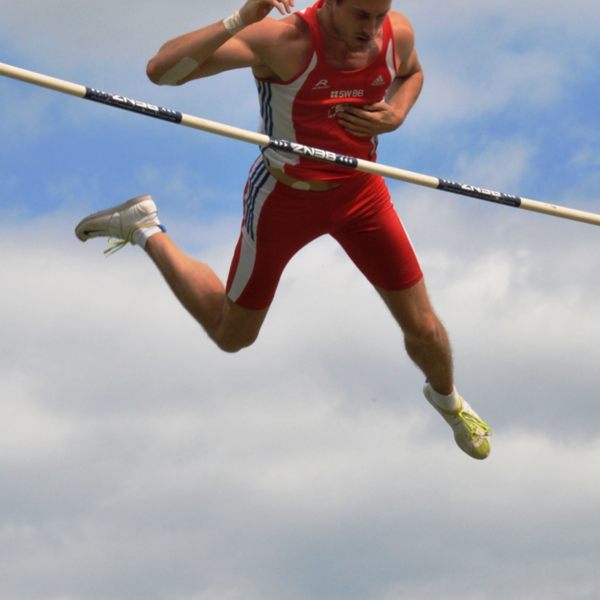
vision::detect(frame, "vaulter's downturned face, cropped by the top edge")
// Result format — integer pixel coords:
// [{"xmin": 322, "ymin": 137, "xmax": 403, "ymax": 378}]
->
[{"xmin": 330, "ymin": 0, "xmax": 392, "ymax": 52}]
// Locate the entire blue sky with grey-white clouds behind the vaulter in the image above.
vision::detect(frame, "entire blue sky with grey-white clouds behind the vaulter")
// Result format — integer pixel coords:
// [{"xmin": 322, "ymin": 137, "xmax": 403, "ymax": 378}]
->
[{"xmin": 0, "ymin": 0, "xmax": 600, "ymax": 600}]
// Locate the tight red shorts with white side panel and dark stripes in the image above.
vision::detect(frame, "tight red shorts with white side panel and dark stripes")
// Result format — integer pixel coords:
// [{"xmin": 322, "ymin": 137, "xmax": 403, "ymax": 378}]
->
[{"xmin": 227, "ymin": 158, "xmax": 423, "ymax": 310}]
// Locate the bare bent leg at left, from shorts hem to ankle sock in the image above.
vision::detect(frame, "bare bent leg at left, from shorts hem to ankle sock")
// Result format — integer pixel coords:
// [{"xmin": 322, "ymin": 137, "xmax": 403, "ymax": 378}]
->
[{"xmin": 146, "ymin": 233, "xmax": 268, "ymax": 352}]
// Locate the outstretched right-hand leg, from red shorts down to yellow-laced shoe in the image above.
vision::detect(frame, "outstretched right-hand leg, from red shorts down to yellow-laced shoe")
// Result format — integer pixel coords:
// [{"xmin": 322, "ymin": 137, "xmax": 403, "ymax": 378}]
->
[{"xmin": 334, "ymin": 173, "xmax": 491, "ymax": 460}]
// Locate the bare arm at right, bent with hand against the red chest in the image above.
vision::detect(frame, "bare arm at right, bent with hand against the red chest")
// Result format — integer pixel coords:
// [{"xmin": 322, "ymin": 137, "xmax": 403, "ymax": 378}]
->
[{"xmin": 338, "ymin": 12, "xmax": 423, "ymax": 137}]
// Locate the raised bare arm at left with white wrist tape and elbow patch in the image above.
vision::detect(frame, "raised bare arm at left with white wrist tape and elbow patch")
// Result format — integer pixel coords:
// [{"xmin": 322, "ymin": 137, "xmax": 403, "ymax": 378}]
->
[{"xmin": 147, "ymin": 0, "xmax": 310, "ymax": 85}]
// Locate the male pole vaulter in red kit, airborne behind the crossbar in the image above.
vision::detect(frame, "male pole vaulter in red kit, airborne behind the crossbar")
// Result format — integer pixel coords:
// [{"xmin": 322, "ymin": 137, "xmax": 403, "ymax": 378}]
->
[{"xmin": 76, "ymin": 0, "xmax": 491, "ymax": 459}]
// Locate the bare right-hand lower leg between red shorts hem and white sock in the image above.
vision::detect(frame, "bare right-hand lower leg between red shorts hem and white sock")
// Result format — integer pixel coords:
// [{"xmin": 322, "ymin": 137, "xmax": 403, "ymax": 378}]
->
[{"xmin": 376, "ymin": 279, "xmax": 454, "ymax": 395}]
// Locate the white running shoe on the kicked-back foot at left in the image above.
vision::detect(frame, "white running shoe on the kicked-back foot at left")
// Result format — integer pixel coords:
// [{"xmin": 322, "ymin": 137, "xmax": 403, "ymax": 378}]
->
[{"xmin": 75, "ymin": 196, "xmax": 166, "ymax": 254}]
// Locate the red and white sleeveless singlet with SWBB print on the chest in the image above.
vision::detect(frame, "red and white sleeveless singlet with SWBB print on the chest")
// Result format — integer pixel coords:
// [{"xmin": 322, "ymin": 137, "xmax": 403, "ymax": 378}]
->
[{"xmin": 255, "ymin": 0, "xmax": 397, "ymax": 181}]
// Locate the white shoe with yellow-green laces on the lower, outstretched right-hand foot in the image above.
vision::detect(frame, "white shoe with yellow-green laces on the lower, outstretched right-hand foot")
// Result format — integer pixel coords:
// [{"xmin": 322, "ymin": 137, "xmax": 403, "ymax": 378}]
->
[{"xmin": 423, "ymin": 383, "xmax": 492, "ymax": 460}]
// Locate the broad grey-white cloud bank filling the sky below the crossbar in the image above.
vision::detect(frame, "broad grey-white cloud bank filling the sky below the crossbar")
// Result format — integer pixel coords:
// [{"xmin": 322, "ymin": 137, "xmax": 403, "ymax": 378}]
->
[{"xmin": 0, "ymin": 192, "xmax": 600, "ymax": 600}]
